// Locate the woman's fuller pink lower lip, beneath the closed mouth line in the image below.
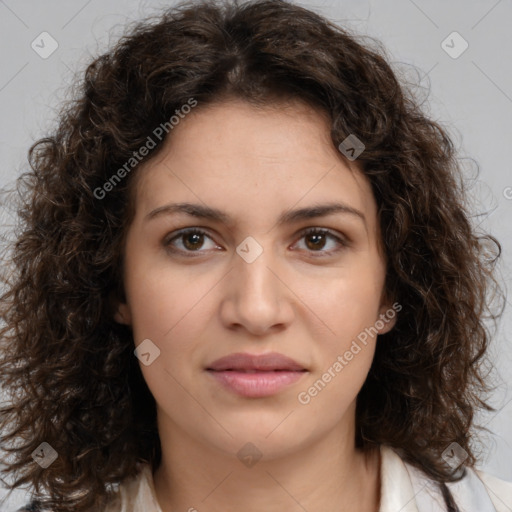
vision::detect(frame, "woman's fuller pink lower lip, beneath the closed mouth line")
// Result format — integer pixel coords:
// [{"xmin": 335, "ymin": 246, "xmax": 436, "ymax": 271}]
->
[{"xmin": 208, "ymin": 370, "xmax": 307, "ymax": 398}]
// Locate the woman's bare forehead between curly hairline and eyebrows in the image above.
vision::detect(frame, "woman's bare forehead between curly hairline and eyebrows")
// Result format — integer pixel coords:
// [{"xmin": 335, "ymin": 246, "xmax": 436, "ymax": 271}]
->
[{"xmin": 132, "ymin": 100, "xmax": 376, "ymax": 231}]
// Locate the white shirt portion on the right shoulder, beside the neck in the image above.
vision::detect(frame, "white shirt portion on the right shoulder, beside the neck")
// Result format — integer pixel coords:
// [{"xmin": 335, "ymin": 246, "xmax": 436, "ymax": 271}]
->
[{"xmin": 379, "ymin": 447, "xmax": 512, "ymax": 512}]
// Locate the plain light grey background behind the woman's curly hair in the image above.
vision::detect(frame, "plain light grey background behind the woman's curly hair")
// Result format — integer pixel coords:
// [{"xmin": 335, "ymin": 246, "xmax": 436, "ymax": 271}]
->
[{"xmin": 0, "ymin": 0, "xmax": 512, "ymax": 512}]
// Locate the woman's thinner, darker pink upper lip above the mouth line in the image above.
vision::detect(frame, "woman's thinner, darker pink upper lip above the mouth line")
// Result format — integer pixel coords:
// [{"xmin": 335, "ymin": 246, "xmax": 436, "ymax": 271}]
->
[{"xmin": 206, "ymin": 352, "xmax": 305, "ymax": 371}]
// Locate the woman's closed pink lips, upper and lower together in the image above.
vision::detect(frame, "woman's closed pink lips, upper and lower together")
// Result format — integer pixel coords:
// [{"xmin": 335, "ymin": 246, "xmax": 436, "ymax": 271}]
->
[{"xmin": 206, "ymin": 352, "xmax": 308, "ymax": 398}]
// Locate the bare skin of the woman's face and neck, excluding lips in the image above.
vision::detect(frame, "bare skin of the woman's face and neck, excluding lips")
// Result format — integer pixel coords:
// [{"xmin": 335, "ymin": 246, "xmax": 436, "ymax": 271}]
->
[{"xmin": 115, "ymin": 100, "xmax": 394, "ymax": 512}]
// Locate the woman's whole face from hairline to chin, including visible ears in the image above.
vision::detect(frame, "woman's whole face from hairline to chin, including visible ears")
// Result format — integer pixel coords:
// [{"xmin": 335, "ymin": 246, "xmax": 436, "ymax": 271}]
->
[{"xmin": 116, "ymin": 101, "xmax": 394, "ymax": 459}]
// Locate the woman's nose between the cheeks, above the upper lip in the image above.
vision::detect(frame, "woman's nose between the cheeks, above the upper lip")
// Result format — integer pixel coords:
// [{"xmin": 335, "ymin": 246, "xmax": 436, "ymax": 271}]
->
[{"xmin": 220, "ymin": 243, "xmax": 294, "ymax": 336}]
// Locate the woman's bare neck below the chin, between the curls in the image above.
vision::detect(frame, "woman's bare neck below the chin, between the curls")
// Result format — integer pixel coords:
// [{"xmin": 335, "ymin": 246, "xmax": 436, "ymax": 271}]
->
[{"xmin": 154, "ymin": 416, "xmax": 380, "ymax": 512}]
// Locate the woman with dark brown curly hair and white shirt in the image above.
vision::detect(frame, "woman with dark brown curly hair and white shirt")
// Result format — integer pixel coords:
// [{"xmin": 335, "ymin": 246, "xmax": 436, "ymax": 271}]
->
[{"xmin": 0, "ymin": 0, "xmax": 512, "ymax": 512}]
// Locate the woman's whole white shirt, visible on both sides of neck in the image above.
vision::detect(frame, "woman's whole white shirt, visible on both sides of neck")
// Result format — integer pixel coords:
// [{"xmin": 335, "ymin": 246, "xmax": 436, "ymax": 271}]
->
[{"xmin": 106, "ymin": 446, "xmax": 512, "ymax": 512}]
